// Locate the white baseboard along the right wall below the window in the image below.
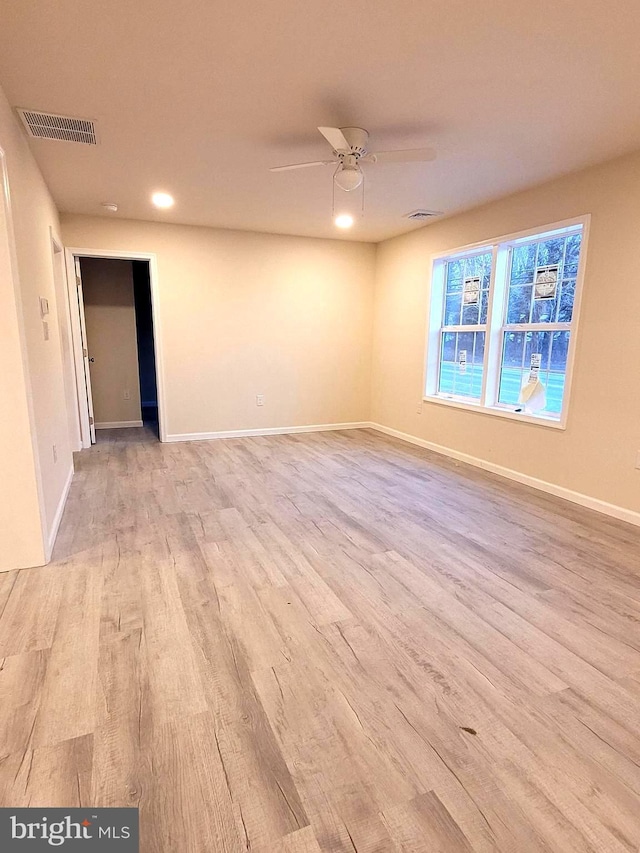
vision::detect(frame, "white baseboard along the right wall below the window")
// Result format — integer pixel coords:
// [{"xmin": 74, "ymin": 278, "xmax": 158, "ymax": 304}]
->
[{"xmin": 369, "ymin": 423, "xmax": 640, "ymax": 526}]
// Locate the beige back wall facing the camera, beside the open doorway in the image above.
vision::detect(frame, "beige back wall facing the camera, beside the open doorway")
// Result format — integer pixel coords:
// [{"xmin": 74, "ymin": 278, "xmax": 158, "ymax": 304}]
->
[{"xmin": 62, "ymin": 216, "xmax": 375, "ymax": 435}]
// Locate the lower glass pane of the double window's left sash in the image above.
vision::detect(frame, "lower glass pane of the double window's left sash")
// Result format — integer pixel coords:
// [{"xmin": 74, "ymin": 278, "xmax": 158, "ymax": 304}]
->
[{"xmin": 438, "ymin": 332, "xmax": 484, "ymax": 400}]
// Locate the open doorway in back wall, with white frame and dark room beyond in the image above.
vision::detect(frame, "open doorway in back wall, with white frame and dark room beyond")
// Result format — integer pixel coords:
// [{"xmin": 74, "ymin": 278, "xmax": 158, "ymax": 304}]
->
[{"xmin": 67, "ymin": 249, "xmax": 164, "ymax": 447}]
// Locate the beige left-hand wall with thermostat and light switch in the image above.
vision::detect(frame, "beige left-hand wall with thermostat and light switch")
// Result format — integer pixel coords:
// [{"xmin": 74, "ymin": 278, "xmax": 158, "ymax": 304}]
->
[{"xmin": 0, "ymin": 83, "xmax": 72, "ymax": 569}]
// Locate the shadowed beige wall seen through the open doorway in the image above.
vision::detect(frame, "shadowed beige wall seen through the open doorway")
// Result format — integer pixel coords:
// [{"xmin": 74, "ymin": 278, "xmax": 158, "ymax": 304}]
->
[{"xmin": 80, "ymin": 258, "xmax": 142, "ymax": 428}]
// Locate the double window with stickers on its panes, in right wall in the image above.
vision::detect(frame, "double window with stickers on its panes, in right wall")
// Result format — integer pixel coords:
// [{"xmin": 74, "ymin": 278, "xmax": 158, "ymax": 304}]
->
[{"xmin": 425, "ymin": 217, "xmax": 588, "ymax": 425}]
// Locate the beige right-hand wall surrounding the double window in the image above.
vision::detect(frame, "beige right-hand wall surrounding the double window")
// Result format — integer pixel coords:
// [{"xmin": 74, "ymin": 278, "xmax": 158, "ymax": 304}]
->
[{"xmin": 372, "ymin": 148, "xmax": 640, "ymax": 511}]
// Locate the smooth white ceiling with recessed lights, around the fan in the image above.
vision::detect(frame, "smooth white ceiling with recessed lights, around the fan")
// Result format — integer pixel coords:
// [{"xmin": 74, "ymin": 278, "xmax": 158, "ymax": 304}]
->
[{"xmin": 0, "ymin": 0, "xmax": 640, "ymax": 241}]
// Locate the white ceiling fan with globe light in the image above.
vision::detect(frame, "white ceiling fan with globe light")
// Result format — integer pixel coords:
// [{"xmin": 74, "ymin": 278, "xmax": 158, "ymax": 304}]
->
[{"xmin": 269, "ymin": 127, "xmax": 436, "ymax": 192}]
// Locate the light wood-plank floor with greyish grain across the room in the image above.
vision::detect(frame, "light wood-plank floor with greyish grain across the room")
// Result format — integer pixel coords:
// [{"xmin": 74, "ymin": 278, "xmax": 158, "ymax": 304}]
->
[{"xmin": 0, "ymin": 430, "xmax": 640, "ymax": 853}]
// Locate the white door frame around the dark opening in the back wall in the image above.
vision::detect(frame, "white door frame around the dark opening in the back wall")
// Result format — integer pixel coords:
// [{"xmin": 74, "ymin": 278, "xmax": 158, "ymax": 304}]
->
[{"xmin": 65, "ymin": 246, "xmax": 167, "ymax": 448}]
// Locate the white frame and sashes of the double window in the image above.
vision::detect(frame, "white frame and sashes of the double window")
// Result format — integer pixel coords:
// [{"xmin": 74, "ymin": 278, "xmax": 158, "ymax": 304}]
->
[{"xmin": 422, "ymin": 214, "xmax": 591, "ymax": 429}]
